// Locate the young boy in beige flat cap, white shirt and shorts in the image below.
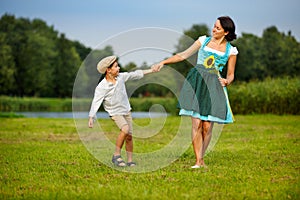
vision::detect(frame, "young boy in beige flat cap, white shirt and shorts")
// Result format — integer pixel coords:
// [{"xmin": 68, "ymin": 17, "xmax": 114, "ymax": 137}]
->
[{"xmin": 88, "ymin": 56, "xmax": 153, "ymax": 167}]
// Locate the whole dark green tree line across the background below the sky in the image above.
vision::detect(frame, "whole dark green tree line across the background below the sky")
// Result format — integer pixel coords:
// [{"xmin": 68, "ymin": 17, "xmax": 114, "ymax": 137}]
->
[{"xmin": 0, "ymin": 14, "xmax": 300, "ymax": 98}]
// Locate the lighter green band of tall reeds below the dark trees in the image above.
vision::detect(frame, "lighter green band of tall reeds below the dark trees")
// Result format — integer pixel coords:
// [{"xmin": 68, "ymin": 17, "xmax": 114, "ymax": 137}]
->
[{"xmin": 0, "ymin": 77, "xmax": 300, "ymax": 115}]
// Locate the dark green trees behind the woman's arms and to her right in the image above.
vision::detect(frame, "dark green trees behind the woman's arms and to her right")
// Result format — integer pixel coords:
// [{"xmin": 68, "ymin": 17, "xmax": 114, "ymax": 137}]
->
[{"xmin": 171, "ymin": 25, "xmax": 300, "ymax": 81}]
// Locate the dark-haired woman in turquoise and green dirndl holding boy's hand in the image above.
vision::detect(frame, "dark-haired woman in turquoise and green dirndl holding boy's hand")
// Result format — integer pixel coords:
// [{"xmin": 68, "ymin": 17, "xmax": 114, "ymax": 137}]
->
[{"xmin": 154, "ymin": 16, "xmax": 238, "ymax": 168}]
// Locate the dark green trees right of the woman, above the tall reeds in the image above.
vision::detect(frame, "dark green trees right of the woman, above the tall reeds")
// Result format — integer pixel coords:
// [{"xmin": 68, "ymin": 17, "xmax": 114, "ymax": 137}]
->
[{"xmin": 233, "ymin": 26, "xmax": 300, "ymax": 81}]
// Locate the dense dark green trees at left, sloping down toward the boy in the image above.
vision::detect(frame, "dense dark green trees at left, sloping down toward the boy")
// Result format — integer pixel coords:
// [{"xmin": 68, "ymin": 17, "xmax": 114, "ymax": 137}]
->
[{"xmin": 0, "ymin": 14, "xmax": 106, "ymax": 98}]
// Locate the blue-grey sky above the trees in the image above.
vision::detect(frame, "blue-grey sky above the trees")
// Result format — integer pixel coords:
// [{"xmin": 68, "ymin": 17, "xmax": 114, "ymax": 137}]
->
[{"xmin": 0, "ymin": 0, "xmax": 300, "ymax": 64}]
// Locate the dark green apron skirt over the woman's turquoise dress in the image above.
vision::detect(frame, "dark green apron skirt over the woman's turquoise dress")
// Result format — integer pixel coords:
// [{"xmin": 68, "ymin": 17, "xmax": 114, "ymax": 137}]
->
[{"xmin": 178, "ymin": 65, "xmax": 229, "ymax": 120}]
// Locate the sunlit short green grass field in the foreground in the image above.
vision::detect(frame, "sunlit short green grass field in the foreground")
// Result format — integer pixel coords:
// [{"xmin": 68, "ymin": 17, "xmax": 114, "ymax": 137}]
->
[{"xmin": 0, "ymin": 115, "xmax": 300, "ymax": 199}]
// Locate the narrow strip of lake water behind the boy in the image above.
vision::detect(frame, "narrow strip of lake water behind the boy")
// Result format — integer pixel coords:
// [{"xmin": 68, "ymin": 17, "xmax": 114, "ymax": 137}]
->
[{"xmin": 16, "ymin": 112, "xmax": 168, "ymax": 119}]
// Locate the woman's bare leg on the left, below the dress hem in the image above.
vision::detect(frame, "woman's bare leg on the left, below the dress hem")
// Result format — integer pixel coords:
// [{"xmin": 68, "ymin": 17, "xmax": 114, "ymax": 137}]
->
[{"xmin": 192, "ymin": 117, "xmax": 203, "ymax": 166}]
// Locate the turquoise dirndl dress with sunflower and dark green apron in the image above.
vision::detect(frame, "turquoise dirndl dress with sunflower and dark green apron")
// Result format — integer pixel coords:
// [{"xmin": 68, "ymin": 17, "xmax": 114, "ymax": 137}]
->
[{"xmin": 178, "ymin": 37, "xmax": 234, "ymax": 124}]
